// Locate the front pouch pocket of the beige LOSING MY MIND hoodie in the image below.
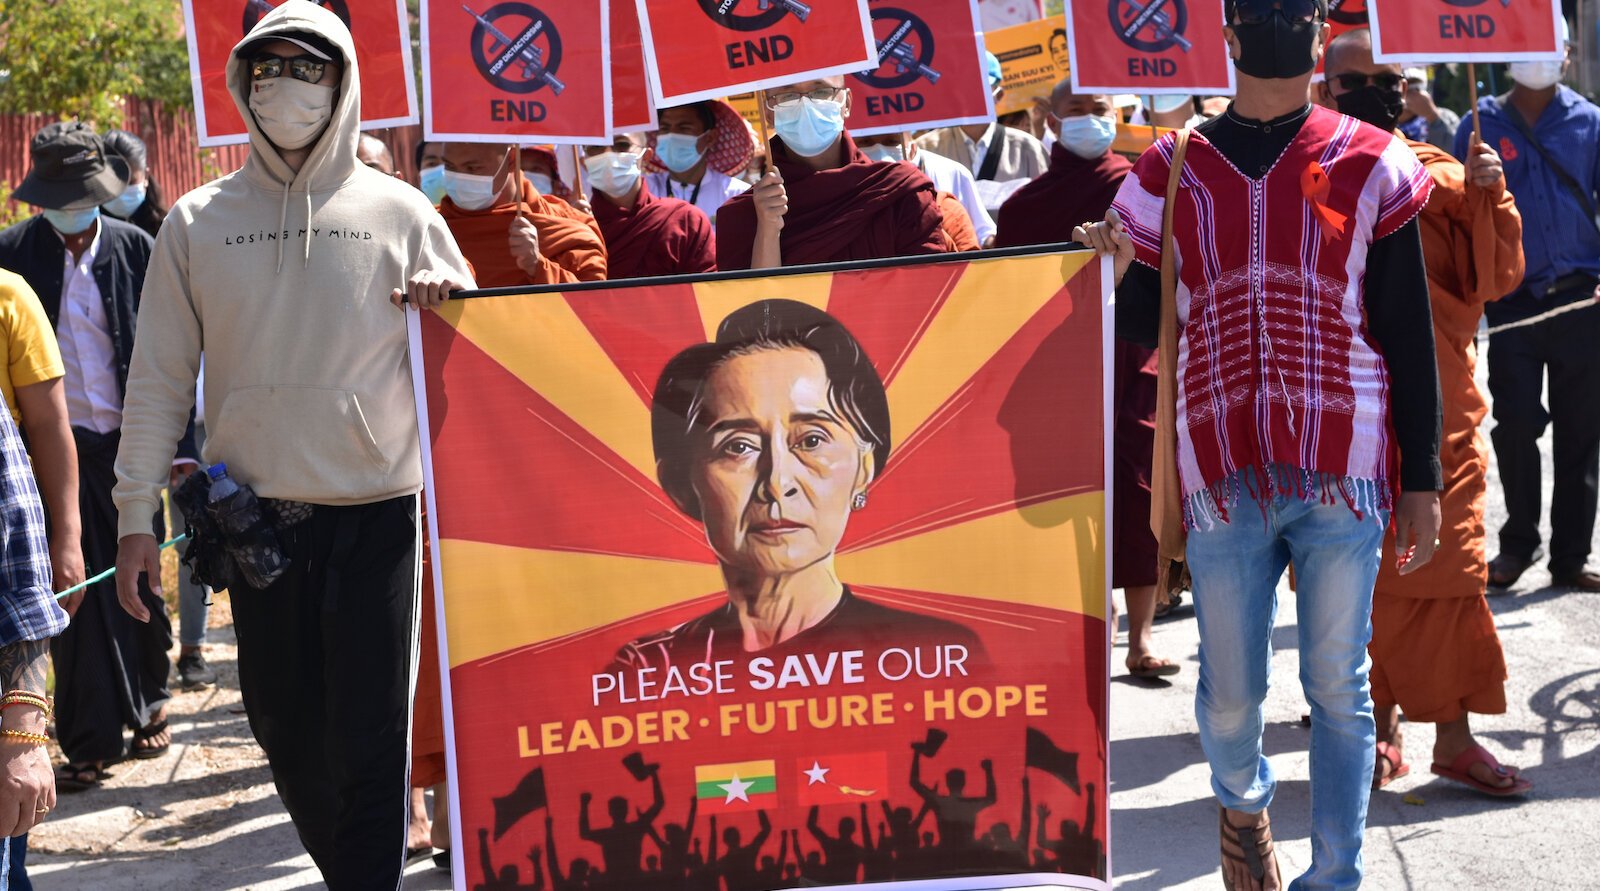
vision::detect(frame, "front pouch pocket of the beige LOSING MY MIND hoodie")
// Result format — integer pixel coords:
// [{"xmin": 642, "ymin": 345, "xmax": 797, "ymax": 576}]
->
[{"xmin": 206, "ymin": 387, "xmax": 392, "ymax": 501}]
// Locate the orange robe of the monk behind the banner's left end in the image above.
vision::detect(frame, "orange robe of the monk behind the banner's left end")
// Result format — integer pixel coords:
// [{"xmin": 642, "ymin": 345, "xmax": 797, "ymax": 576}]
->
[{"xmin": 438, "ymin": 179, "xmax": 606, "ymax": 288}]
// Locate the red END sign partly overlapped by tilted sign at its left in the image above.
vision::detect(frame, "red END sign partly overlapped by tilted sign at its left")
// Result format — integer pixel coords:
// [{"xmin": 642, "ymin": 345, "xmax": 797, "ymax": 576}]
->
[{"xmin": 845, "ymin": 0, "xmax": 994, "ymax": 136}]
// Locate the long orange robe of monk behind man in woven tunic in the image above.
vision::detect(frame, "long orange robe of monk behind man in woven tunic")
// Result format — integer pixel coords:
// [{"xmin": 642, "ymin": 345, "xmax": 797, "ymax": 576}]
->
[{"xmin": 1370, "ymin": 141, "xmax": 1523, "ymax": 723}]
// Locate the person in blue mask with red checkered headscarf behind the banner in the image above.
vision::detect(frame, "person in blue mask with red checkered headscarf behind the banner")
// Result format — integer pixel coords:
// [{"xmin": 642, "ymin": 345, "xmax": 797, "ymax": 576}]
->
[{"xmin": 645, "ymin": 99, "xmax": 755, "ymax": 222}]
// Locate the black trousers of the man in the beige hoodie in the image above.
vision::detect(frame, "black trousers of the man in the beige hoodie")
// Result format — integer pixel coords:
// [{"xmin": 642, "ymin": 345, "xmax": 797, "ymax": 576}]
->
[{"xmin": 230, "ymin": 496, "xmax": 419, "ymax": 891}]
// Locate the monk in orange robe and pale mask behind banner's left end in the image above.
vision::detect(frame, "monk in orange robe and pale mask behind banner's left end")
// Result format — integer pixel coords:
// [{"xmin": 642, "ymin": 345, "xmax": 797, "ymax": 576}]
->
[{"xmin": 438, "ymin": 142, "xmax": 606, "ymax": 288}]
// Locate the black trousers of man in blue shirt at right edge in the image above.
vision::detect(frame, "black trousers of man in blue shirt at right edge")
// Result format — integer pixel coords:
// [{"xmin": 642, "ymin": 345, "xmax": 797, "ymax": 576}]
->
[{"xmin": 1490, "ymin": 296, "xmax": 1600, "ymax": 574}]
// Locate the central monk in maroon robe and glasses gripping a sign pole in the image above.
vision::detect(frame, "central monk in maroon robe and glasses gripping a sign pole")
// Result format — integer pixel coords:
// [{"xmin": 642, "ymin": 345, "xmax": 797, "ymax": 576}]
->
[{"xmin": 717, "ymin": 77, "xmax": 949, "ymax": 269}]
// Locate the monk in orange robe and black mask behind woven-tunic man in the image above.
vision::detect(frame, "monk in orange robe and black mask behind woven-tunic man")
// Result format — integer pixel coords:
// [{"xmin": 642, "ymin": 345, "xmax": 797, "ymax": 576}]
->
[{"xmin": 1318, "ymin": 29, "xmax": 1531, "ymax": 795}]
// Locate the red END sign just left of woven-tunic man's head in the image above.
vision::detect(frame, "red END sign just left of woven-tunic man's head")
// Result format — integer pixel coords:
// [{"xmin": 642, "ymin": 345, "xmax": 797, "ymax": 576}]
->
[{"xmin": 1067, "ymin": 0, "xmax": 1234, "ymax": 96}]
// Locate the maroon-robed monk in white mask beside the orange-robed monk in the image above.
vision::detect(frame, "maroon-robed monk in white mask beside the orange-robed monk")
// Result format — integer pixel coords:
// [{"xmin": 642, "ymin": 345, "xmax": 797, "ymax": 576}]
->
[{"xmin": 584, "ymin": 133, "xmax": 717, "ymax": 280}]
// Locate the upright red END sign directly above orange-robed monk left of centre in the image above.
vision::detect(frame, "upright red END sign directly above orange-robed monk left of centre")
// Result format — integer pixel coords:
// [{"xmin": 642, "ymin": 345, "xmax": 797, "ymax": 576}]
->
[{"xmin": 422, "ymin": 0, "xmax": 611, "ymax": 144}]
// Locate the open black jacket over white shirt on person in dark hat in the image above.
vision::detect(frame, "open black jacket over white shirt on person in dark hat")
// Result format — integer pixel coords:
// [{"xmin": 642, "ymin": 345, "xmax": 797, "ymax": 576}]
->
[{"xmin": 0, "ymin": 214, "xmax": 198, "ymax": 461}]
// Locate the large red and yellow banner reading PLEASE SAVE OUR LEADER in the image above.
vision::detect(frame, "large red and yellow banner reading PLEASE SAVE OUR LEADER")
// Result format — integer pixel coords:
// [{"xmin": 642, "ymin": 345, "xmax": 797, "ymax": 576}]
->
[{"xmin": 410, "ymin": 251, "xmax": 1110, "ymax": 889}]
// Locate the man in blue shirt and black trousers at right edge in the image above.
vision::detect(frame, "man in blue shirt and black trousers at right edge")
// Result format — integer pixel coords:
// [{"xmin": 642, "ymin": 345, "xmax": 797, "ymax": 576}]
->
[{"xmin": 1456, "ymin": 22, "xmax": 1600, "ymax": 590}]
